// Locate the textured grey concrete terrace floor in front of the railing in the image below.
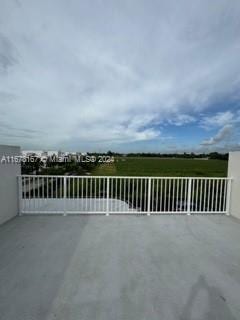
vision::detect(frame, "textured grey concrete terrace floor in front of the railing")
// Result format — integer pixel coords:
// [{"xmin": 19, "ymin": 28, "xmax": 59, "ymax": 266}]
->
[{"xmin": 0, "ymin": 216, "xmax": 240, "ymax": 320}]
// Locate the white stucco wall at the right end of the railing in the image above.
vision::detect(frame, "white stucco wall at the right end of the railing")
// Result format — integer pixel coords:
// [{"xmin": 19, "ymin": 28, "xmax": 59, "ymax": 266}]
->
[{"xmin": 228, "ymin": 151, "xmax": 240, "ymax": 219}]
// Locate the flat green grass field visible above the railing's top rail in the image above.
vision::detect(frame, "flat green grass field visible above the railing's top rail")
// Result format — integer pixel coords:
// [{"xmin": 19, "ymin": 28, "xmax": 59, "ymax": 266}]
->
[{"xmin": 92, "ymin": 157, "xmax": 228, "ymax": 177}]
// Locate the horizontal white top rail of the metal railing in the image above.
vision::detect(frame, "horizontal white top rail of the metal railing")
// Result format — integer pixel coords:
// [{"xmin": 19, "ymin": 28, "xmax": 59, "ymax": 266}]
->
[{"xmin": 18, "ymin": 174, "xmax": 233, "ymax": 180}]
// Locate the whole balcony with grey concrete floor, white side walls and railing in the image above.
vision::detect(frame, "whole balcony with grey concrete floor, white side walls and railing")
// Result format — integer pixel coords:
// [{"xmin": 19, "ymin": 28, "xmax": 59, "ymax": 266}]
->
[{"xmin": 0, "ymin": 146, "xmax": 240, "ymax": 320}]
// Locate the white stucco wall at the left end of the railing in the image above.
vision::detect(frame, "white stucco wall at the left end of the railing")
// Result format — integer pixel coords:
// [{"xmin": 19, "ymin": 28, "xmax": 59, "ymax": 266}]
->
[{"xmin": 0, "ymin": 145, "xmax": 21, "ymax": 224}]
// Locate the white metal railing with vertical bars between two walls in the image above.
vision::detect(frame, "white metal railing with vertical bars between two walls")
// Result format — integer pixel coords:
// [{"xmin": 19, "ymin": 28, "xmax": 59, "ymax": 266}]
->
[{"xmin": 18, "ymin": 175, "xmax": 231, "ymax": 215}]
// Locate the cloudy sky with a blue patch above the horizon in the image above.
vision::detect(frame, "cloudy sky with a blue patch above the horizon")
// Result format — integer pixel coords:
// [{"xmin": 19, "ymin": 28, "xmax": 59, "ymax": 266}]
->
[{"xmin": 0, "ymin": 0, "xmax": 240, "ymax": 152}]
